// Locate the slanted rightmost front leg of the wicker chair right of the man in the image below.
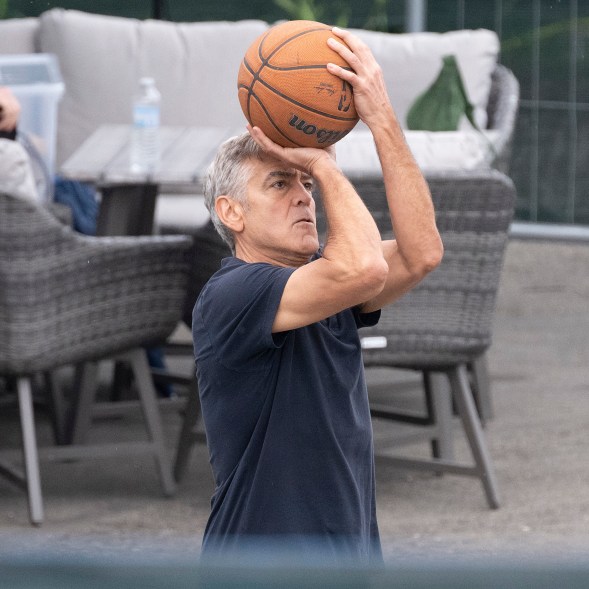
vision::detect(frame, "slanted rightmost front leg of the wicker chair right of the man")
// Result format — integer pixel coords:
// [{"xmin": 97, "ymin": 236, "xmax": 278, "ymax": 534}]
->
[{"xmin": 448, "ymin": 365, "xmax": 500, "ymax": 509}]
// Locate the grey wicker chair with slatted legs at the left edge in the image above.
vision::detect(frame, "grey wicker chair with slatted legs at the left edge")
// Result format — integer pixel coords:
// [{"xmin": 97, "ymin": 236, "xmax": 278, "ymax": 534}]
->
[{"xmin": 0, "ymin": 193, "xmax": 191, "ymax": 524}]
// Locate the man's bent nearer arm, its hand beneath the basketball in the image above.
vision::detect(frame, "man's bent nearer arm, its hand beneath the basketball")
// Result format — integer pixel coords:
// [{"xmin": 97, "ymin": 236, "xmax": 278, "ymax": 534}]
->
[{"xmin": 246, "ymin": 128, "xmax": 388, "ymax": 333}]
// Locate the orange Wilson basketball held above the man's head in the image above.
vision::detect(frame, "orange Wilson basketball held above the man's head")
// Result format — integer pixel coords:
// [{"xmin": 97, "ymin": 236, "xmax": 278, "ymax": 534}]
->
[{"xmin": 237, "ymin": 20, "xmax": 358, "ymax": 148}]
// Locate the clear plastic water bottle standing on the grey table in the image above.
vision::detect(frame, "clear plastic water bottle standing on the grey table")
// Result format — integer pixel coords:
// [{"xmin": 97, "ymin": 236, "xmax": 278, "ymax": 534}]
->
[{"xmin": 131, "ymin": 78, "xmax": 161, "ymax": 174}]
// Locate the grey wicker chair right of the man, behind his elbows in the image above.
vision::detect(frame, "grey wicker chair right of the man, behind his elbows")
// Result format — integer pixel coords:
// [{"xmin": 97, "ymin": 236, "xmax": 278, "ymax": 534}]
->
[{"xmin": 355, "ymin": 170, "xmax": 515, "ymax": 508}]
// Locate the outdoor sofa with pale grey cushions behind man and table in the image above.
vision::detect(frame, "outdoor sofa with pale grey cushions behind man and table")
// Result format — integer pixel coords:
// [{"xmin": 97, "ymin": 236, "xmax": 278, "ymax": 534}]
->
[{"xmin": 0, "ymin": 8, "xmax": 518, "ymax": 226}]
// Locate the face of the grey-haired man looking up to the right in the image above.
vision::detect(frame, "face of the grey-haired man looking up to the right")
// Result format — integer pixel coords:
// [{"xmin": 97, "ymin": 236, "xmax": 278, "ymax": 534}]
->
[{"xmin": 236, "ymin": 159, "xmax": 319, "ymax": 266}]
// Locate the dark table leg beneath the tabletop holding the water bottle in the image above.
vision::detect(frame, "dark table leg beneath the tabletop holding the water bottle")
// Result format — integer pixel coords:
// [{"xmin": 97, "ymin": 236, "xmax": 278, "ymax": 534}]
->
[{"xmin": 96, "ymin": 184, "xmax": 159, "ymax": 235}]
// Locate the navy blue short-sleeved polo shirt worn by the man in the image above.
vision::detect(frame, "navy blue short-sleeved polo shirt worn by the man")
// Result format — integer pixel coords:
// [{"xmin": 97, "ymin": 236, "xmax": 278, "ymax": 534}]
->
[{"xmin": 192, "ymin": 258, "xmax": 382, "ymax": 562}]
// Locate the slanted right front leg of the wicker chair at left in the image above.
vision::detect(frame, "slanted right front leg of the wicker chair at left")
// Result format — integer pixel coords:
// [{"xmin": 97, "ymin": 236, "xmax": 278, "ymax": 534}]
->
[{"xmin": 126, "ymin": 349, "xmax": 176, "ymax": 497}]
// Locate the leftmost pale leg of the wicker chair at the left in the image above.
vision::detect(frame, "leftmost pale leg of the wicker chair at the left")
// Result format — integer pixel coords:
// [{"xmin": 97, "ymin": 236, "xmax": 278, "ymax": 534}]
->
[{"xmin": 17, "ymin": 378, "xmax": 43, "ymax": 525}]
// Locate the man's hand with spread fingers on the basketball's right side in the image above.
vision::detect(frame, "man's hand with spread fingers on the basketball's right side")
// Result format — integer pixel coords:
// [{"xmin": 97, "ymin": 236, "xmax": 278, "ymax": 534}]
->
[{"xmin": 327, "ymin": 27, "xmax": 395, "ymax": 130}]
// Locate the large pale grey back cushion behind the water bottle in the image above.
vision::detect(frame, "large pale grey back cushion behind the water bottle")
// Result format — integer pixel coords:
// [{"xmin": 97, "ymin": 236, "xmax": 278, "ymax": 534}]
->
[{"xmin": 39, "ymin": 9, "xmax": 268, "ymax": 163}]
